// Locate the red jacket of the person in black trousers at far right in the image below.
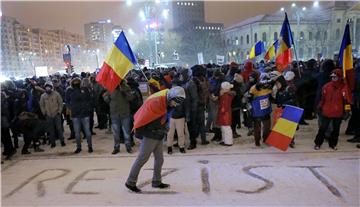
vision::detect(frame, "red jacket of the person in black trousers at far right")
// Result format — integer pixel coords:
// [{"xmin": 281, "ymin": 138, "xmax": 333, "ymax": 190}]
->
[{"xmin": 319, "ymin": 81, "xmax": 351, "ymax": 118}]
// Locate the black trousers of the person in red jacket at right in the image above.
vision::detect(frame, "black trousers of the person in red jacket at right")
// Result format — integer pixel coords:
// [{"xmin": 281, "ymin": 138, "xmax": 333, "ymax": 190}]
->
[{"xmin": 314, "ymin": 117, "xmax": 342, "ymax": 147}]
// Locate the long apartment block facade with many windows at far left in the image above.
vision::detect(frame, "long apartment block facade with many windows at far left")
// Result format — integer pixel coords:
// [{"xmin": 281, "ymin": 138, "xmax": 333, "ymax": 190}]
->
[{"xmin": 1, "ymin": 16, "xmax": 106, "ymax": 77}]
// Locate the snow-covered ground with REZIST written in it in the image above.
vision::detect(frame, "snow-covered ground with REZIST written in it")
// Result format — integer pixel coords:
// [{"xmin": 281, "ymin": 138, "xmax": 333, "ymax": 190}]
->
[{"xmin": 1, "ymin": 120, "xmax": 360, "ymax": 206}]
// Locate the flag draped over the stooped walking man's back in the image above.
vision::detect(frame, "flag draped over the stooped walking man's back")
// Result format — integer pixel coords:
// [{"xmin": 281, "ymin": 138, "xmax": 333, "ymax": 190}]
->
[{"xmin": 134, "ymin": 89, "xmax": 169, "ymax": 129}]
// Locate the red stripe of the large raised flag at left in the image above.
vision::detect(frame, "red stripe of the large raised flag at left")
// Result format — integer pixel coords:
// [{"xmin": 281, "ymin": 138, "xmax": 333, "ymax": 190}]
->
[{"xmin": 96, "ymin": 62, "xmax": 121, "ymax": 93}]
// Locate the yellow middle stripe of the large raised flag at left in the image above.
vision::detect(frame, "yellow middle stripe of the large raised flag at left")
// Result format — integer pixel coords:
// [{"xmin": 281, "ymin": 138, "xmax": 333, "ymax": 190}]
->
[{"xmin": 105, "ymin": 45, "xmax": 134, "ymax": 79}]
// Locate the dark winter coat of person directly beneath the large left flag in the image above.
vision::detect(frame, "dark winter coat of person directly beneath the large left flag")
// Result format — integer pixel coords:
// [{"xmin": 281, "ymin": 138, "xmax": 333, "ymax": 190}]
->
[{"xmin": 104, "ymin": 83, "xmax": 134, "ymax": 118}]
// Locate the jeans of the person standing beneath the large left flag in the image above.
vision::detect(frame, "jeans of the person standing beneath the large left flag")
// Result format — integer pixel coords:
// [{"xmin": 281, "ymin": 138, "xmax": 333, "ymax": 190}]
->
[{"xmin": 111, "ymin": 116, "xmax": 131, "ymax": 149}]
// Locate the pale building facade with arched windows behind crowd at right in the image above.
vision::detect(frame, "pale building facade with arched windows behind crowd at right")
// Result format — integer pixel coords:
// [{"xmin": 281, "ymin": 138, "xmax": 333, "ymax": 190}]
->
[{"xmin": 223, "ymin": 2, "xmax": 360, "ymax": 62}]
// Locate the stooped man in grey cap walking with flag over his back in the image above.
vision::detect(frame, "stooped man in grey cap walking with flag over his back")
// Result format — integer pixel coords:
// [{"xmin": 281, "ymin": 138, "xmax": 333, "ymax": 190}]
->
[{"xmin": 125, "ymin": 86, "xmax": 186, "ymax": 193}]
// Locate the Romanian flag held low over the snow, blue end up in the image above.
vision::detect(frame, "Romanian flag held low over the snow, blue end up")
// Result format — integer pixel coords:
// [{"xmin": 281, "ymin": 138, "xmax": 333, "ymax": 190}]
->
[{"xmin": 265, "ymin": 105, "xmax": 304, "ymax": 151}]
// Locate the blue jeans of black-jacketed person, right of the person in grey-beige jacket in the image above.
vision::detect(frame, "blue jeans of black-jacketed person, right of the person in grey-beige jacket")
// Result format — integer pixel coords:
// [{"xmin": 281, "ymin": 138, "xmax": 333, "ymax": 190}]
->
[{"xmin": 72, "ymin": 117, "xmax": 92, "ymax": 149}]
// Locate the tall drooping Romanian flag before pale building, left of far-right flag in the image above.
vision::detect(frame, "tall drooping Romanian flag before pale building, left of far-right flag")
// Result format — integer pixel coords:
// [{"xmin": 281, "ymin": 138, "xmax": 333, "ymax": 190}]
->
[{"xmin": 275, "ymin": 12, "xmax": 294, "ymax": 72}]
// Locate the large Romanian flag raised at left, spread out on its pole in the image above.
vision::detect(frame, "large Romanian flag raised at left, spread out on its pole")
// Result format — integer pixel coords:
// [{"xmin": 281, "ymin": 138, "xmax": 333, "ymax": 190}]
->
[{"xmin": 96, "ymin": 32, "xmax": 136, "ymax": 93}]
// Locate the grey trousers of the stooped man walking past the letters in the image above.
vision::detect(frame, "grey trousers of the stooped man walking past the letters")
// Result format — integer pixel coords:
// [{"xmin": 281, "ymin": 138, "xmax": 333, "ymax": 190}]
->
[{"xmin": 126, "ymin": 137, "xmax": 164, "ymax": 186}]
